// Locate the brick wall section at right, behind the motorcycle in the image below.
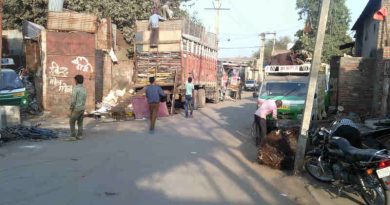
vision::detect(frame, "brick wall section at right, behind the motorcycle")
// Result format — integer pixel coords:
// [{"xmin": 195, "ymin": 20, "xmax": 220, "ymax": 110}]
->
[{"xmin": 331, "ymin": 57, "xmax": 376, "ymax": 115}]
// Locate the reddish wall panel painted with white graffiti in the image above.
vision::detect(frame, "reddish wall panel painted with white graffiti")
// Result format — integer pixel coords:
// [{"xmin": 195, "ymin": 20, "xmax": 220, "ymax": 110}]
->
[{"xmin": 41, "ymin": 31, "xmax": 96, "ymax": 115}]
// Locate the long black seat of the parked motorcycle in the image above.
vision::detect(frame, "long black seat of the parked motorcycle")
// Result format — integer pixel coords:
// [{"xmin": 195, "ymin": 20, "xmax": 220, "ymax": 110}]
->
[{"xmin": 331, "ymin": 137, "xmax": 378, "ymax": 162}]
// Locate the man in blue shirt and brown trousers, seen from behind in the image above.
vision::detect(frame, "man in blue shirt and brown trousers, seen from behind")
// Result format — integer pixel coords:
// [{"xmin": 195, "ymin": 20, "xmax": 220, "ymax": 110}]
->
[{"xmin": 146, "ymin": 77, "xmax": 165, "ymax": 132}]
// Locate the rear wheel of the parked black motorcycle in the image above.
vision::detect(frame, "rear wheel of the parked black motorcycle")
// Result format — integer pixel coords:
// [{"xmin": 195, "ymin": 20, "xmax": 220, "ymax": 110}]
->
[{"xmin": 360, "ymin": 176, "xmax": 390, "ymax": 205}]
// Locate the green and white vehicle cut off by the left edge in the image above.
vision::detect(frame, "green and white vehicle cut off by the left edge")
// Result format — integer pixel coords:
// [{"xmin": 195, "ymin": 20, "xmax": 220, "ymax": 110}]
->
[{"xmin": 0, "ymin": 62, "xmax": 28, "ymax": 108}]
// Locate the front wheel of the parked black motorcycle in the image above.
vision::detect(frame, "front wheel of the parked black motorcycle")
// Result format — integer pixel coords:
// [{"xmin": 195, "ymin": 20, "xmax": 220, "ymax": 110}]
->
[{"xmin": 305, "ymin": 157, "xmax": 333, "ymax": 182}]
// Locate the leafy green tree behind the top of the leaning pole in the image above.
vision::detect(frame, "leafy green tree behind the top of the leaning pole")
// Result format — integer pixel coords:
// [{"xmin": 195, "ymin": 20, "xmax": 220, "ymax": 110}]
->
[{"xmin": 294, "ymin": 0, "xmax": 351, "ymax": 63}]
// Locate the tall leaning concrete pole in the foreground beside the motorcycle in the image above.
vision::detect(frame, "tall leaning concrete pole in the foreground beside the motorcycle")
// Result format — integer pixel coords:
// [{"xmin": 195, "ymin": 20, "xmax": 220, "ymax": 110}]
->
[{"xmin": 294, "ymin": 0, "xmax": 330, "ymax": 174}]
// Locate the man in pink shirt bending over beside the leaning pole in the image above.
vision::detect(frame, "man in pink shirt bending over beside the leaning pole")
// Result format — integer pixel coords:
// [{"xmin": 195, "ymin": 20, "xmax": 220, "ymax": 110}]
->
[{"xmin": 255, "ymin": 100, "xmax": 283, "ymax": 146}]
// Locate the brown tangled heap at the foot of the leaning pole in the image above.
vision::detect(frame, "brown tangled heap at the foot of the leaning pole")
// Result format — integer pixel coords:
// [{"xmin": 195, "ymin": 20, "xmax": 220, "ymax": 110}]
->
[{"xmin": 257, "ymin": 128, "xmax": 299, "ymax": 170}]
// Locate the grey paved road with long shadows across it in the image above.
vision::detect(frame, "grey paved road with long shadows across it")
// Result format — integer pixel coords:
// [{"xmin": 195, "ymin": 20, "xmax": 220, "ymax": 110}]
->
[{"xmin": 0, "ymin": 93, "xmax": 362, "ymax": 205}]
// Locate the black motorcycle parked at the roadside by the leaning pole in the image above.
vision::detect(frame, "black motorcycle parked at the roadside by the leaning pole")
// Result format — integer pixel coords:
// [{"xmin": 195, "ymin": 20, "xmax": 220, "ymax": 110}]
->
[{"xmin": 305, "ymin": 124, "xmax": 390, "ymax": 205}]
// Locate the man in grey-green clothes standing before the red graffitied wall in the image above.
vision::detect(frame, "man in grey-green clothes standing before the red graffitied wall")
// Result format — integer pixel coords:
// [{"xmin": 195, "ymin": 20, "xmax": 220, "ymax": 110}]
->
[{"xmin": 68, "ymin": 75, "xmax": 87, "ymax": 141}]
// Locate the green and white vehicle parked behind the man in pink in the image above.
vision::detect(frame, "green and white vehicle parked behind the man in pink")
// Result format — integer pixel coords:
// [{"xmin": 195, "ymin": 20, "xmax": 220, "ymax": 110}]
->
[{"xmin": 258, "ymin": 63, "xmax": 329, "ymax": 121}]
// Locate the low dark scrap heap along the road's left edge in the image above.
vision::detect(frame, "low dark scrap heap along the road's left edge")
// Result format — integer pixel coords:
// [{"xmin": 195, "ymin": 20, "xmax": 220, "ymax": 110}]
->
[{"xmin": 0, "ymin": 126, "xmax": 58, "ymax": 142}]
